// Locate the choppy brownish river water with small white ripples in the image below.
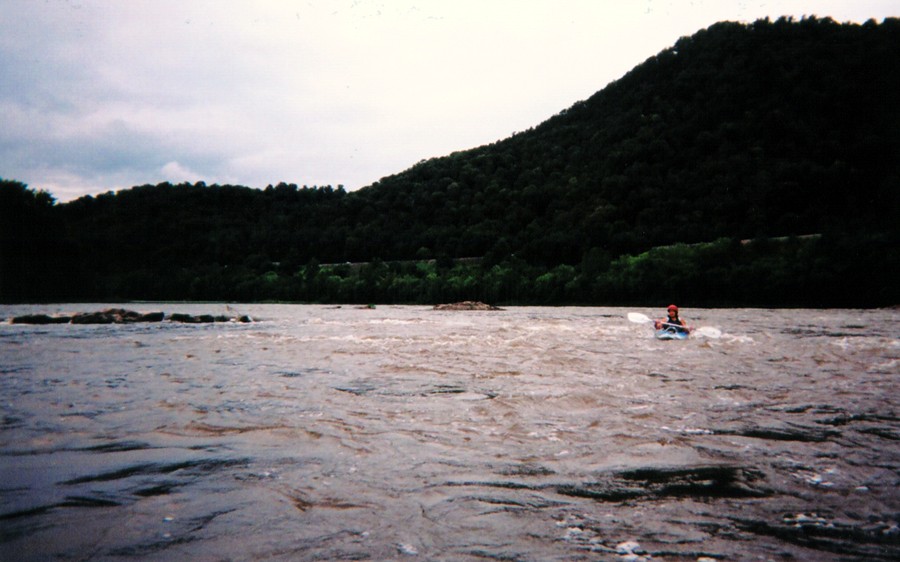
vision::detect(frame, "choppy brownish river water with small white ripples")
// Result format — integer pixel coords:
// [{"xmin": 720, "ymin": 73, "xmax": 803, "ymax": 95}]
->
[{"xmin": 0, "ymin": 304, "xmax": 900, "ymax": 562}]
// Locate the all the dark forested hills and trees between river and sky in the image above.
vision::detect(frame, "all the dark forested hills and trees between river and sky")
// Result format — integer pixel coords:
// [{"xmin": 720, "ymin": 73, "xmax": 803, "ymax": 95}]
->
[{"xmin": 0, "ymin": 18, "xmax": 900, "ymax": 306}]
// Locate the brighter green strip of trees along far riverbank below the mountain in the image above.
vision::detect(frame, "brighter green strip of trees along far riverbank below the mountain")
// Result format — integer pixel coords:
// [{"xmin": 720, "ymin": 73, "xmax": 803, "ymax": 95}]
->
[{"xmin": 123, "ymin": 236, "xmax": 900, "ymax": 307}]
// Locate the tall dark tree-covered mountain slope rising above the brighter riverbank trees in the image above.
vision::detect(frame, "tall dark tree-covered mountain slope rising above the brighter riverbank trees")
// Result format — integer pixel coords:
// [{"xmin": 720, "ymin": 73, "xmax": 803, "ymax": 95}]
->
[{"xmin": 360, "ymin": 15, "xmax": 900, "ymax": 265}]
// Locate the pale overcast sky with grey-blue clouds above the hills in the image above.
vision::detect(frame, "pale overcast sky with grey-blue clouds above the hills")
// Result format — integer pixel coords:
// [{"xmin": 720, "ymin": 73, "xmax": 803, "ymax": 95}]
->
[{"xmin": 0, "ymin": 0, "xmax": 900, "ymax": 202}]
